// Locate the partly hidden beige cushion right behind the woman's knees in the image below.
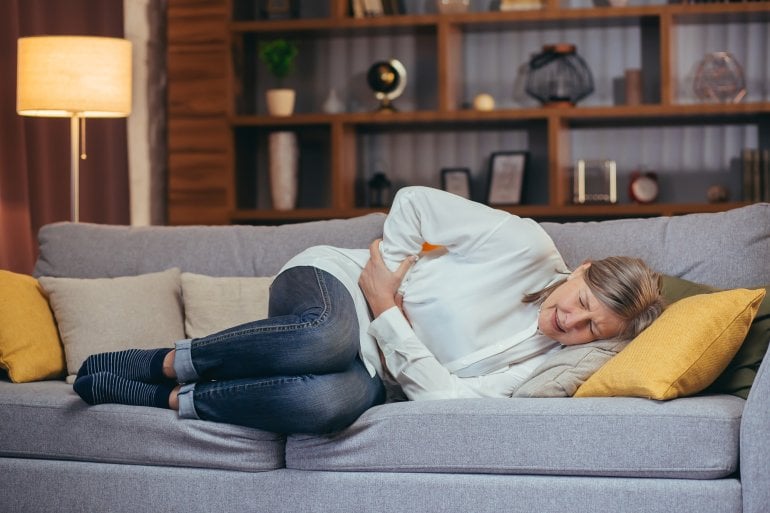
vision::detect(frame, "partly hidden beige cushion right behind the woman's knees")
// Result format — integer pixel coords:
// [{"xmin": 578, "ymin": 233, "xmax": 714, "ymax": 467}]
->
[{"xmin": 182, "ymin": 273, "xmax": 274, "ymax": 338}]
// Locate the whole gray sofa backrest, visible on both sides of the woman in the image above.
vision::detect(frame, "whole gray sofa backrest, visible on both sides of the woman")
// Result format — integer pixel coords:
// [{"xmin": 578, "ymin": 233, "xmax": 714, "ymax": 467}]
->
[{"xmin": 35, "ymin": 203, "xmax": 770, "ymax": 288}]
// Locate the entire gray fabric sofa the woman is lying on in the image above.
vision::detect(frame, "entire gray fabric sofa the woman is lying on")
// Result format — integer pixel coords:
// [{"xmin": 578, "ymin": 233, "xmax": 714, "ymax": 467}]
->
[{"xmin": 0, "ymin": 204, "xmax": 770, "ymax": 513}]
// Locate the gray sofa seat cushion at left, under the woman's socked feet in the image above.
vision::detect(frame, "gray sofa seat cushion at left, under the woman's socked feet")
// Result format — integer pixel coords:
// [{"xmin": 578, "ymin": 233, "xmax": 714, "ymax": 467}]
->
[{"xmin": 0, "ymin": 381, "xmax": 285, "ymax": 472}]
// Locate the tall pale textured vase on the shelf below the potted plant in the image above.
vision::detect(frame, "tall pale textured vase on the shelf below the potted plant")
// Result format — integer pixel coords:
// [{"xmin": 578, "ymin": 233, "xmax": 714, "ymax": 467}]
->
[{"xmin": 268, "ymin": 132, "xmax": 299, "ymax": 210}]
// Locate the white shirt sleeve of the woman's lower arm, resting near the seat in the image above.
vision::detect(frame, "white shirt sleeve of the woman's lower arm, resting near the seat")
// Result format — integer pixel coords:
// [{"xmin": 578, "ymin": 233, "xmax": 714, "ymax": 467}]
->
[{"xmin": 368, "ymin": 307, "xmax": 482, "ymax": 401}]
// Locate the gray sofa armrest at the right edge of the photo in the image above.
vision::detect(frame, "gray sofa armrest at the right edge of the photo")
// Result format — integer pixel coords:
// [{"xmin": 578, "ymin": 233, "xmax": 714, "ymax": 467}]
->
[{"xmin": 740, "ymin": 353, "xmax": 770, "ymax": 513}]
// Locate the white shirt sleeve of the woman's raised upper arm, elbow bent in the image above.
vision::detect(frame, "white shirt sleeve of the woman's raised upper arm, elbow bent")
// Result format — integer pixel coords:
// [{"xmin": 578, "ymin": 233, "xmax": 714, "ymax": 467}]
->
[{"xmin": 381, "ymin": 186, "xmax": 511, "ymax": 269}]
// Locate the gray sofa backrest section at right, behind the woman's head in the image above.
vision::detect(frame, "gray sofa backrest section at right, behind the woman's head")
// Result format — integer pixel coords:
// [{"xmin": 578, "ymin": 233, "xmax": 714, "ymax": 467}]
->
[{"xmin": 542, "ymin": 203, "xmax": 770, "ymax": 288}]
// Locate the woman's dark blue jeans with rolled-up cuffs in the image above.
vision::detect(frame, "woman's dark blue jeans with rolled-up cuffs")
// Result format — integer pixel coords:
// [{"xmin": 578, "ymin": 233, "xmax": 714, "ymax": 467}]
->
[{"xmin": 174, "ymin": 267, "xmax": 385, "ymax": 433}]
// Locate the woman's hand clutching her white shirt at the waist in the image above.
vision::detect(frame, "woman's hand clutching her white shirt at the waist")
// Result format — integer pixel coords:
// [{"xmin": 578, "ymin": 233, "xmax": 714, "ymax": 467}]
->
[{"xmin": 358, "ymin": 239, "xmax": 417, "ymax": 317}]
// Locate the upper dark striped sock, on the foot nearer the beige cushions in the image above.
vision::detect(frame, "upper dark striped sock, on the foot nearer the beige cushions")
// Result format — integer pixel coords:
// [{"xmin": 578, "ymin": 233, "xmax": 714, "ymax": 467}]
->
[{"xmin": 77, "ymin": 347, "xmax": 171, "ymax": 383}]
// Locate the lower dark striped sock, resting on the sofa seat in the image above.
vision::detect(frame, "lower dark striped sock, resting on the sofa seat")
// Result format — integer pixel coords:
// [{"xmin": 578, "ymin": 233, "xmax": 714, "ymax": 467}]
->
[{"xmin": 72, "ymin": 372, "xmax": 174, "ymax": 408}]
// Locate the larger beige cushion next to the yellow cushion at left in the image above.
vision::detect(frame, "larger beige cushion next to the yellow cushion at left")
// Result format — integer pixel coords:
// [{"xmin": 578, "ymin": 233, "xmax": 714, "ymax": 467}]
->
[{"xmin": 39, "ymin": 268, "xmax": 184, "ymax": 381}]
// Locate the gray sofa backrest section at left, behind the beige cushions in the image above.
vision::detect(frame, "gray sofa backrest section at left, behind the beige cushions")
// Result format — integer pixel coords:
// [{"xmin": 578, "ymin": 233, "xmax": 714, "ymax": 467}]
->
[{"xmin": 34, "ymin": 214, "xmax": 385, "ymax": 278}]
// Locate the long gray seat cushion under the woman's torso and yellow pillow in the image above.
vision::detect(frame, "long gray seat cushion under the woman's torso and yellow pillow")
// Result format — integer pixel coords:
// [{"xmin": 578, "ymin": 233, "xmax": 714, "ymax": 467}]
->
[{"xmin": 286, "ymin": 395, "xmax": 745, "ymax": 479}]
